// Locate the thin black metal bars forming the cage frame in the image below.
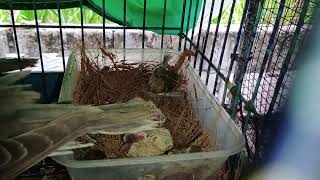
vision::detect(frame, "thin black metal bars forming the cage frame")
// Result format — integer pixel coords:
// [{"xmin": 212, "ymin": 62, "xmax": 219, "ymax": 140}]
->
[{"xmin": 0, "ymin": 0, "xmax": 318, "ymax": 178}]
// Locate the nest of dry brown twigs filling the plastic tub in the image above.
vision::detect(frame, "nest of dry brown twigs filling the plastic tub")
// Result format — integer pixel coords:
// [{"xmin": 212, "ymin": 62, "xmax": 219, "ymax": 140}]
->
[{"xmin": 74, "ymin": 45, "xmax": 213, "ymax": 158}]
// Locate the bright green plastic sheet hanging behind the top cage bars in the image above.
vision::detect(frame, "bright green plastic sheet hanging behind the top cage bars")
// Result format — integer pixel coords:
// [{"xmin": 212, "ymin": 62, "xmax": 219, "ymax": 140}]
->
[{"xmin": 88, "ymin": 0, "xmax": 202, "ymax": 35}]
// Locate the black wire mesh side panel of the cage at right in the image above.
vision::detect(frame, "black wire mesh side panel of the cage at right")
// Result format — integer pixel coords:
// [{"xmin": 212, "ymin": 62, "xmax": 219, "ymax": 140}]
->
[{"xmin": 235, "ymin": 0, "xmax": 318, "ymax": 161}]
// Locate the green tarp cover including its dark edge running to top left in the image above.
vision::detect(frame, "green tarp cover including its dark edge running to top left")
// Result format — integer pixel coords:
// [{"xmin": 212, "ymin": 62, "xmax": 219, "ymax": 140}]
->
[{"xmin": 0, "ymin": 0, "xmax": 203, "ymax": 35}]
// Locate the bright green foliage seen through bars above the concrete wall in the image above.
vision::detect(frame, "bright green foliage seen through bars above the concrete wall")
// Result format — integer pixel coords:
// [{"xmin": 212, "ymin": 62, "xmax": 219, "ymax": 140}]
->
[{"xmin": 0, "ymin": 0, "xmax": 315, "ymax": 25}]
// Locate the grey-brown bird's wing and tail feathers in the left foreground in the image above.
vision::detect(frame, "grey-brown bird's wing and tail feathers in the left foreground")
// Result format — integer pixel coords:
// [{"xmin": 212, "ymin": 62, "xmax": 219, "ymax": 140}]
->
[{"xmin": 0, "ymin": 71, "xmax": 163, "ymax": 179}]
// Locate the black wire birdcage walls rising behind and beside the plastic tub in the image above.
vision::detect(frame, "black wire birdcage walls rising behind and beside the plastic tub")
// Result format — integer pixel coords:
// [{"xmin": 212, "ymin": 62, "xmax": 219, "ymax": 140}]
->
[{"xmin": 0, "ymin": 0, "xmax": 318, "ymax": 177}]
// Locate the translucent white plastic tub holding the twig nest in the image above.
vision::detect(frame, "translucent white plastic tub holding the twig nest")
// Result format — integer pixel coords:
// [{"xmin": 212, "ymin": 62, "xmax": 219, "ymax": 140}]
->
[{"xmin": 53, "ymin": 49, "xmax": 244, "ymax": 180}]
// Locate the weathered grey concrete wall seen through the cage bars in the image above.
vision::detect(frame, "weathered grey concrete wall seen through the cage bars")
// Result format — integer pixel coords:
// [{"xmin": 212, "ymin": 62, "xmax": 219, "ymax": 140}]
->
[{"xmin": 0, "ymin": 25, "xmax": 294, "ymax": 111}]
